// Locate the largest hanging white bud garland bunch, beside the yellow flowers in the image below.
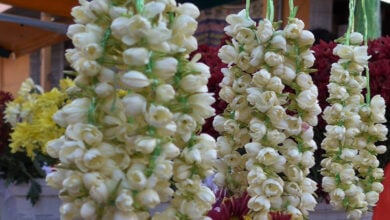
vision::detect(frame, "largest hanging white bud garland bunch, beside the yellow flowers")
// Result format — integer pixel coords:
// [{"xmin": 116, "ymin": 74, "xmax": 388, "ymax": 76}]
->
[{"xmin": 47, "ymin": 0, "xmax": 217, "ymax": 220}]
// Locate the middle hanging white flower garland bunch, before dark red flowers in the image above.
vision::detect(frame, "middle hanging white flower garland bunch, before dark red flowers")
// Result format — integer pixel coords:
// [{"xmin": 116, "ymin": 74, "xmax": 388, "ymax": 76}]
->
[{"xmin": 213, "ymin": 10, "xmax": 321, "ymax": 219}]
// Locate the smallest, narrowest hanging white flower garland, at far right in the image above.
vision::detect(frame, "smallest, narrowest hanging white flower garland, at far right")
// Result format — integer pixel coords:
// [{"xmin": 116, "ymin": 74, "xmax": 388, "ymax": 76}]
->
[{"xmin": 321, "ymin": 32, "xmax": 387, "ymax": 219}]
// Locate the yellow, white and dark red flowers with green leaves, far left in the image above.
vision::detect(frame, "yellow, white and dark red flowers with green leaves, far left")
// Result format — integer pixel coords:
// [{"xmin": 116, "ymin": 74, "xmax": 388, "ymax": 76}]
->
[{"xmin": 0, "ymin": 78, "xmax": 71, "ymax": 205}]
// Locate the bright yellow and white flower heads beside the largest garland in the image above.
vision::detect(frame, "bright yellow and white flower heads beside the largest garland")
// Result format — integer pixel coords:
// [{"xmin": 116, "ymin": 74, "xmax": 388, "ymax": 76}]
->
[{"xmin": 5, "ymin": 78, "xmax": 71, "ymax": 157}]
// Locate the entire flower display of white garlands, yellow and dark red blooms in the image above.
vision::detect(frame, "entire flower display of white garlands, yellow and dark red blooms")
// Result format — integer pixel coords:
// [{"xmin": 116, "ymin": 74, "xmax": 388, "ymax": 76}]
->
[{"xmin": 0, "ymin": 0, "xmax": 390, "ymax": 220}]
